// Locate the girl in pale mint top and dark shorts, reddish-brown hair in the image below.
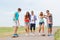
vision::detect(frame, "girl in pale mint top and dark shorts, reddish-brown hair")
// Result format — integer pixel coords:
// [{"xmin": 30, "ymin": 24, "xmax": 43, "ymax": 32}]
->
[{"xmin": 39, "ymin": 12, "xmax": 45, "ymax": 36}]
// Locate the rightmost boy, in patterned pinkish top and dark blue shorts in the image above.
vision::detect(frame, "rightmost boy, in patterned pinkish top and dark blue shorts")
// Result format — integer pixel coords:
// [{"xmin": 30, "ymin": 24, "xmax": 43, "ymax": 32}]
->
[{"xmin": 46, "ymin": 10, "xmax": 53, "ymax": 36}]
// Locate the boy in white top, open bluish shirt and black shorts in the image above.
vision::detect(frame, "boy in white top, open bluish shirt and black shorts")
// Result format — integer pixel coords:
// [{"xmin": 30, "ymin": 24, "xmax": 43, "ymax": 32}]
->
[{"xmin": 30, "ymin": 11, "xmax": 37, "ymax": 32}]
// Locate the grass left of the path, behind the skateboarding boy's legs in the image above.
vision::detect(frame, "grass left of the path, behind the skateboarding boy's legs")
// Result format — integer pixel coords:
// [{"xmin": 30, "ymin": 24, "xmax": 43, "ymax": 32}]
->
[{"xmin": 0, "ymin": 27, "xmax": 24, "ymax": 38}]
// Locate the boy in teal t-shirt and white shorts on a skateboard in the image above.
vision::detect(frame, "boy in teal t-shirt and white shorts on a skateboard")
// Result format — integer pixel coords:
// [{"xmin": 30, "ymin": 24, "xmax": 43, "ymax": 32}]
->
[{"xmin": 13, "ymin": 8, "xmax": 21, "ymax": 37}]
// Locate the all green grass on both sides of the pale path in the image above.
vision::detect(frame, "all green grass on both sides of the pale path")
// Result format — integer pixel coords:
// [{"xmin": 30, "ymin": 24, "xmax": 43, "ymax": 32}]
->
[{"xmin": 0, "ymin": 27, "xmax": 60, "ymax": 40}]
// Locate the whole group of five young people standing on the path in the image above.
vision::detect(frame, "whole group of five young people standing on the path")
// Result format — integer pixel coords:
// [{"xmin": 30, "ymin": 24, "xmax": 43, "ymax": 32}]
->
[{"xmin": 13, "ymin": 8, "xmax": 53, "ymax": 37}]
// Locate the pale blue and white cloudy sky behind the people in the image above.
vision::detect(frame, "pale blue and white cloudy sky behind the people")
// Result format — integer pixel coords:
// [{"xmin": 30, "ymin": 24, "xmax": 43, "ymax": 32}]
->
[{"xmin": 0, "ymin": 0, "xmax": 60, "ymax": 27}]
